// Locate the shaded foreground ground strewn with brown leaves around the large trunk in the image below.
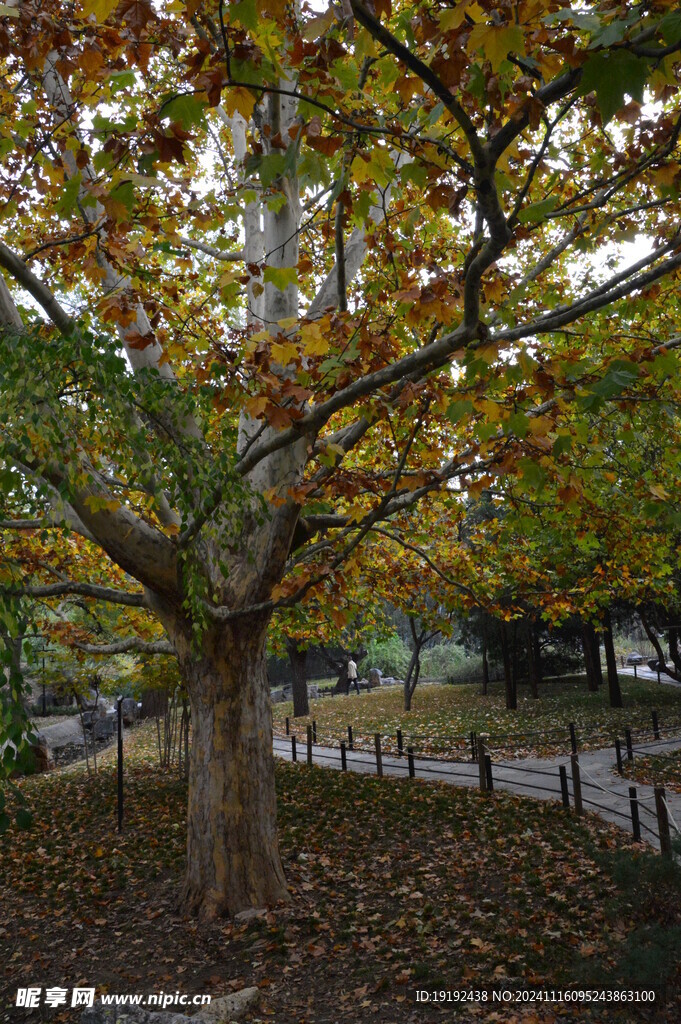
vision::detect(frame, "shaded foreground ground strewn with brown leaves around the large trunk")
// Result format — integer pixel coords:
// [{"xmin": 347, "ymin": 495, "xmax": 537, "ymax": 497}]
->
[{"xmin": 0, "ymin": 727, "xmax": 681, "ymax": 1024}]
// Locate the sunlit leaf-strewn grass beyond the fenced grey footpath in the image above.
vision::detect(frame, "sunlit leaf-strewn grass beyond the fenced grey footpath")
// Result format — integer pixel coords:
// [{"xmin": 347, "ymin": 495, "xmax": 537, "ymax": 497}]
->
[{"xmin": 273, "ymin": 676, "xmax": 681, "ymax": 757}]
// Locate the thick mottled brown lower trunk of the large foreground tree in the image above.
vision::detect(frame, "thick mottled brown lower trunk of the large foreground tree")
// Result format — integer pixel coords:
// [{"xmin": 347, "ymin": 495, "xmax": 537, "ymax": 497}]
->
[{"xmin": 173, "ymin": 616, "xmax": 288, "ymax": 920}]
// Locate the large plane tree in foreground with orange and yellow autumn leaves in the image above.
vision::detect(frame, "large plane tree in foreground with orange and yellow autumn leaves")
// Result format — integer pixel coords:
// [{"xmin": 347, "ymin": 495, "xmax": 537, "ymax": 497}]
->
[{"xmin": 0, "ymin": 0, "xmax": 681, "ymax": 916}]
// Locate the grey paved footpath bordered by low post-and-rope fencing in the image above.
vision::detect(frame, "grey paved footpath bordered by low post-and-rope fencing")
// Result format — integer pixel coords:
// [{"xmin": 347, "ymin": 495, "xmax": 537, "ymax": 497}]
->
[{"xmin": 273, "ymin": 736, "xmax": 681, "ymax": 849}]
